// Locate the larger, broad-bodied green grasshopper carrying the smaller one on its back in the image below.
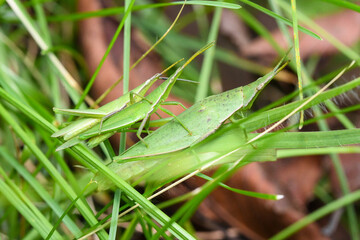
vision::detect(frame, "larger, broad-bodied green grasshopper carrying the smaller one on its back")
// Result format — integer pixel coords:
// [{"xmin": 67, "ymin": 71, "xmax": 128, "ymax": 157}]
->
[{"xmin": 114, "ymin": 52, "xmax": 288, "ymax": 161}]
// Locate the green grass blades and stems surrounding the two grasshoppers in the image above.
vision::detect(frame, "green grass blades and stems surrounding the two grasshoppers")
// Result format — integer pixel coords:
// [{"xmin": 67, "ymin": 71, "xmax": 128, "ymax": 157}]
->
[{"xmin": 0, "ymin": 0, "xmax": 360, "ymax": 239}]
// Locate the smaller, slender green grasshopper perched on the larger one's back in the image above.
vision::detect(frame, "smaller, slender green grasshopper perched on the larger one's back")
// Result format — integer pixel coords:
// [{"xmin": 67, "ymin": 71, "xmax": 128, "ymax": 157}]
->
[{"xmin": 53, "ymin": 43, "xmax": 214, "ymax": 150}]
